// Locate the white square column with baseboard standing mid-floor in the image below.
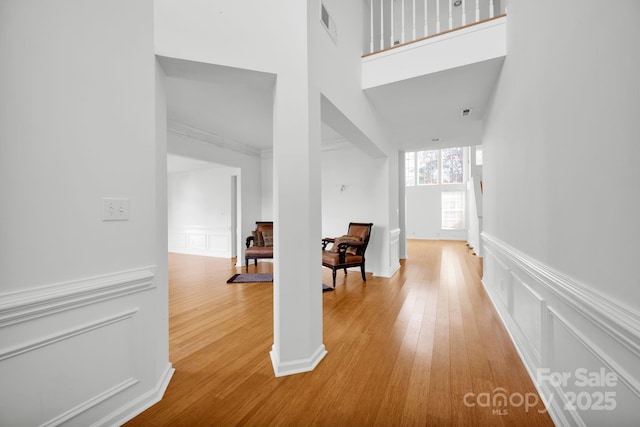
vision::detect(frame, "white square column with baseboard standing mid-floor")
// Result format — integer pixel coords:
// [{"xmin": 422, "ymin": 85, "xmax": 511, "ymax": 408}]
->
[{"xmin": 270, "ymin": 0, "xmax": 326, "ymax": 376}]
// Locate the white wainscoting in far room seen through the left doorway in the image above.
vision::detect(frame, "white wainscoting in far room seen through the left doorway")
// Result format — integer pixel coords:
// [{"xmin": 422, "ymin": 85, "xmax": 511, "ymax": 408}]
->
[{"xmin": 169, "ymin": 227, "xmax": 231, "ymax": 258}]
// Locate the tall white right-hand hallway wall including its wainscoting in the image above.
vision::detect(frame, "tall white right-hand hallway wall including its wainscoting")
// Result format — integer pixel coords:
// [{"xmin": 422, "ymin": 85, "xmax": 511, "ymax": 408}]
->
[{"xmin": 483, "ymin": 0, "xmax": 640, "ymax": 425}]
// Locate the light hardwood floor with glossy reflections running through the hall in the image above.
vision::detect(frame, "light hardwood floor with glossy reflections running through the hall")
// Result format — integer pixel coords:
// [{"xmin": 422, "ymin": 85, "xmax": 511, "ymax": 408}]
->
[{"xmin": 127, "ymin": 240, "xmax": 553, "ymax": 426}]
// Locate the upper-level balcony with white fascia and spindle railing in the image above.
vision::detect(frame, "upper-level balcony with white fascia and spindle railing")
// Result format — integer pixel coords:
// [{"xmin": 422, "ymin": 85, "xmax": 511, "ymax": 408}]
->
[{"xmin": 362, "ymin": 0, "xmax": 507, "ymax": 89}]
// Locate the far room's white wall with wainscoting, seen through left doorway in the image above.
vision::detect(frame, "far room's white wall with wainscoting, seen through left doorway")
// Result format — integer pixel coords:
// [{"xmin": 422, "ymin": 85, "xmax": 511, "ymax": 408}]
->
[{"xmin": 168, "ymin": 167, "xmax": 237, "ymax": 258}]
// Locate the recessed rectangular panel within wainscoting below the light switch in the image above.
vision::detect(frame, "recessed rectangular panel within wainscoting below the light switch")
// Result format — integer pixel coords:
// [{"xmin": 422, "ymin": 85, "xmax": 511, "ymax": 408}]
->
[{"xmin": 0, "ymin": 310, "xmax": 139, "ymax": 425}]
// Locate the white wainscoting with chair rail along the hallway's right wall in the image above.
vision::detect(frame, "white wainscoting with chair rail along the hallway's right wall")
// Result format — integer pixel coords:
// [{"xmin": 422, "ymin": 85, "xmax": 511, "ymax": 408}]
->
[{"xmin": 482, "ymin": 233, "xmax": 640, "ymax": 426}]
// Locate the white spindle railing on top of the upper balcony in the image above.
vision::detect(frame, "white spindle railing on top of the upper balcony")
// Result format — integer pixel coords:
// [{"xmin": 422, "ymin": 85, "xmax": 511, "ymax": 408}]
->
[{"xmin": 363, "ymin": 0, "xmax": 506, "ymax": 55}]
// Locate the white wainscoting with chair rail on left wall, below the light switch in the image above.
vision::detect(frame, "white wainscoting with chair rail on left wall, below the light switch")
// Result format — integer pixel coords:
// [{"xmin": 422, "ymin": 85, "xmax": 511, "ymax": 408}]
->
[{"xmin": 0, "ymin": 266, "xmax": 172, "ymax": 426}]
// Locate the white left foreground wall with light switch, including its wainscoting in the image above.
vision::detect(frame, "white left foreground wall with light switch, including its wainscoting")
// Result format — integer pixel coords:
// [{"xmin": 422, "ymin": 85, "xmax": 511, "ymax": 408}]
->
[{"xmin": 0, "ymin": 0, "xmax": 172, "ymax": 426}]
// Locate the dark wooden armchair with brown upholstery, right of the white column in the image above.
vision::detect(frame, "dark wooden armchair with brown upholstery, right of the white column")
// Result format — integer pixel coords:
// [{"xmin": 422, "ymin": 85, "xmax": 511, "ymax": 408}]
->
[{"xmin": 322, "ymin": 222, "xmax": 373, "ymax": 289}]
